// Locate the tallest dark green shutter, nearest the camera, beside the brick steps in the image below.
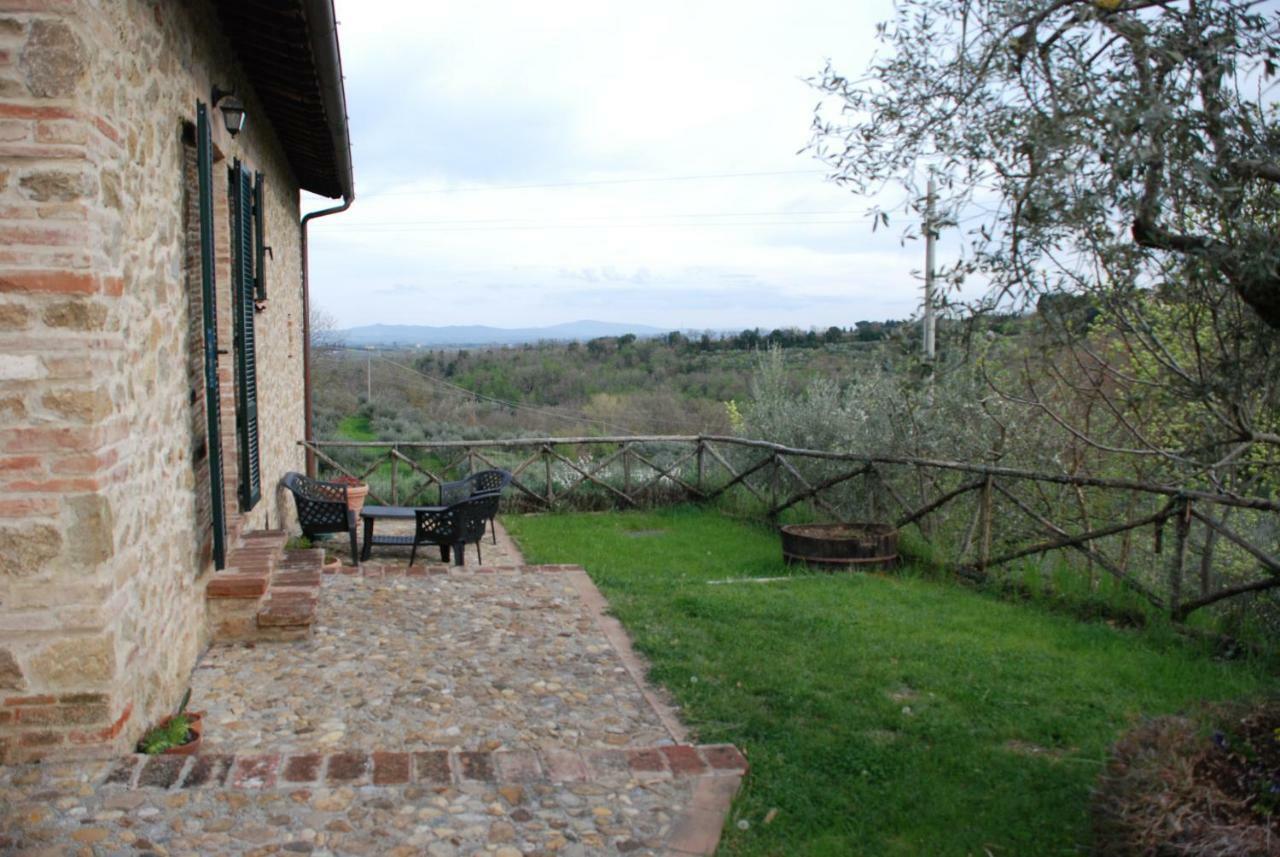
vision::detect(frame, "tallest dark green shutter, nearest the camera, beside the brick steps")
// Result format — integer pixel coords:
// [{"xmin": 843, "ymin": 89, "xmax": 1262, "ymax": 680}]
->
[{"xmin": 196, "ymin": 101, "xmax": 227, "ymax": 569}]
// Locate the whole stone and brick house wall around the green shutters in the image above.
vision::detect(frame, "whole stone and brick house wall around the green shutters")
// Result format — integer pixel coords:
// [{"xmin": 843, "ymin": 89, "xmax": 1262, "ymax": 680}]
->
[{"xmin": 0, "ymin": 0, "xmax": 316, "ymax": 761}]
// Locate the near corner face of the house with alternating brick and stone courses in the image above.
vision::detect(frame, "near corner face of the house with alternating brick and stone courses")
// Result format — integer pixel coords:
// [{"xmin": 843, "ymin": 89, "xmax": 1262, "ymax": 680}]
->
[{"xmin": 0, "ymin": 4, "xmax": 126, "ymax": 761}]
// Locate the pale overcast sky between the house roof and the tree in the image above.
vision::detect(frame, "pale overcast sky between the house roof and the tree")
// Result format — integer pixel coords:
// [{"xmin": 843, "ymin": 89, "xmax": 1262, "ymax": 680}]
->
[{"xmin": 303, "ymin": 0, "xmax": 923, "ymax": 330}]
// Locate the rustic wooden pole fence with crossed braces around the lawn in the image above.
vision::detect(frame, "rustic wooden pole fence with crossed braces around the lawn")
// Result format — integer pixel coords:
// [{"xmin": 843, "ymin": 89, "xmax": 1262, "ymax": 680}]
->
[{"xmin": 302, "ymin": 435, "xmax": 1280, "ymax": 620}]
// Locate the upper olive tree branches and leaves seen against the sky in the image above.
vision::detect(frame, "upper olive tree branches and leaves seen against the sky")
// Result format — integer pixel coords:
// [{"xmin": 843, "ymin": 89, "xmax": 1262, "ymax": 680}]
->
[{"xmin": 812, "ymin": 0, "xmax": 1280, "ymax": 331}]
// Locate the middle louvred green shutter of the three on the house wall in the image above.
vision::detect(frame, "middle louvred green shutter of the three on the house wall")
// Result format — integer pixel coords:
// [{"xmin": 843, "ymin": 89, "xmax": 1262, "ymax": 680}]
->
[{"xmin": 230, "ymin": 161, "xmax": 262, "ymax": 512}]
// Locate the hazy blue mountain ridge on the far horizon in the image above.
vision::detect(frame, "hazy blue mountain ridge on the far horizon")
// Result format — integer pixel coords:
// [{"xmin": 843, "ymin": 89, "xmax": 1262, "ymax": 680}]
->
[{"xmin": 335, "ymin": 321, "xmax": 668, "ymax": 347}]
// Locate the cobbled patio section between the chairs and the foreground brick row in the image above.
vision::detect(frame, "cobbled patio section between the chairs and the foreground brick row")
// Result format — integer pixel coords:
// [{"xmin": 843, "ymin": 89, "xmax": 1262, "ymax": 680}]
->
[{"xmin": 192, "ymin": 519, "xmax": 671, "ymax": 753}]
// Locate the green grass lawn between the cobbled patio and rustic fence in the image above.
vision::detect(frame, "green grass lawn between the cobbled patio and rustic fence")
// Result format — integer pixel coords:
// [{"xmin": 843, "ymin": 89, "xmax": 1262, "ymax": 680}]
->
[{"xmin": 504, "ymin": 508, "xmax": 1275, "ymax": 857}]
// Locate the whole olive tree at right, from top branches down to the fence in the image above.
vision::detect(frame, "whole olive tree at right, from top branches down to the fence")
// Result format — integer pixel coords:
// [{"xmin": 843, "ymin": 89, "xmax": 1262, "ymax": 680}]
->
[{"xmin": 812, "ymin": 0, "xmax": 1280, "ymax": 487}]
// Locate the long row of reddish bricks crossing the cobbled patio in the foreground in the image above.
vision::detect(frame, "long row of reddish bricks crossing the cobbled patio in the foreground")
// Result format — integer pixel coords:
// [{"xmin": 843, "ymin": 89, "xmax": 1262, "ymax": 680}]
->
[{"xmin": 102, "ymin": 744, "xmax": 748, "ymax": 789}]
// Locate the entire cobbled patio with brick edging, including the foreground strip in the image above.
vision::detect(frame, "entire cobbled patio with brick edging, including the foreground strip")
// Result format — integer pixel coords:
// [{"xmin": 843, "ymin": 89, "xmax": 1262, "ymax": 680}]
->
[{"xmin": 0, "ymin": 527, "xmax": 746, "ymax": 857}]
